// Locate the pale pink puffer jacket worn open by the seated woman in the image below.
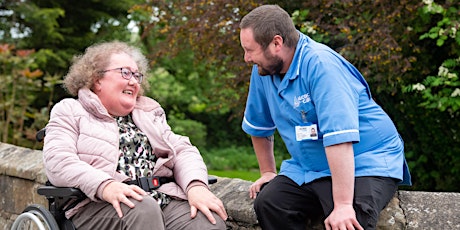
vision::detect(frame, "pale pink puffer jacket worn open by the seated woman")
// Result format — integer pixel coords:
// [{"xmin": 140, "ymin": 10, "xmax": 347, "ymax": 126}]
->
[{"xmin": 43, "ymin": 89, "xmax": 208, "ymax": 217}]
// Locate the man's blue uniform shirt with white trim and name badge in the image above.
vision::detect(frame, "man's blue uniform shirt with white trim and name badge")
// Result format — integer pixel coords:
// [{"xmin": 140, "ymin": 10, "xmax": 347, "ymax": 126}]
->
[{"xmin": 242, "ymin": 33, "xmax": 411, "ymax": 185}]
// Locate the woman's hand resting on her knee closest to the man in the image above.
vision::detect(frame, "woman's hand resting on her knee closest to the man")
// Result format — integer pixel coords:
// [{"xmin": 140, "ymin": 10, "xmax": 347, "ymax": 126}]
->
[{"xmin": 187, "ymin": 186, "xmax": 228, "ymax": 224}]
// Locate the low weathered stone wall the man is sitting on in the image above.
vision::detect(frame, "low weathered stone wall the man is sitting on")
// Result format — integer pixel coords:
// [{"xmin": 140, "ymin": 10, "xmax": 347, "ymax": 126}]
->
[{"xmin": 0, "ymin": 143, "xmax": 460, "ymax": 230}]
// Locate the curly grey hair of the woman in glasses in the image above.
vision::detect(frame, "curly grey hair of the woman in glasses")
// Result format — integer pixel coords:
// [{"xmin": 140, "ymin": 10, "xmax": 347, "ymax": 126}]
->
[{"xmin": 64, "ymin": 41, "xmax": 149, "ymax": 96}]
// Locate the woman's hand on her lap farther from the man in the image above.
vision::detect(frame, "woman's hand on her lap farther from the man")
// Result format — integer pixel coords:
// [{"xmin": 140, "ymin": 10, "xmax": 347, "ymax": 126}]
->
[{"xmin": 102, "ymin": 181, "xmax": 147, "ymax": 218}]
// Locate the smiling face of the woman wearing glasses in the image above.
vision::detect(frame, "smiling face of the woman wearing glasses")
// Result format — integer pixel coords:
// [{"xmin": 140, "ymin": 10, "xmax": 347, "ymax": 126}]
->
[{"xmin": 94, "ymin": 53, "xmax": 140, "ymax": 116}]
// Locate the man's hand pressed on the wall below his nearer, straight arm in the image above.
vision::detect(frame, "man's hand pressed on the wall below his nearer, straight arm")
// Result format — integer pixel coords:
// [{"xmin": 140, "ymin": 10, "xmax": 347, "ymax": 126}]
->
[{"xmin": 324, "ymin": 204, "xmax": 364, "ymax": 230}]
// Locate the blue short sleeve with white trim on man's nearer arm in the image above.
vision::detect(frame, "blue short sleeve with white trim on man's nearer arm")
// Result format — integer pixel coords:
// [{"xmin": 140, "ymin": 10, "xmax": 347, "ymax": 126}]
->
[{"xmin": 304, "ymin": 50, "xmax": 365, "ymax": 147}]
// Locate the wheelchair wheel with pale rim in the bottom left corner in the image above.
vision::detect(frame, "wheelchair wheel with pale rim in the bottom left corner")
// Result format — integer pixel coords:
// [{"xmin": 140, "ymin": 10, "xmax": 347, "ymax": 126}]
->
[{"xmin": 11, "ymin": 204, "xmax": 59, "ymax": 230}]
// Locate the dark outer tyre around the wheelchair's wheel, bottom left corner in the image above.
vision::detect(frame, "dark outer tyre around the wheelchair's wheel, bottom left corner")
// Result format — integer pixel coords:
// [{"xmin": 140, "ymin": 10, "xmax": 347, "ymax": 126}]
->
[{"xmin": 12, "ymin": 204, "xmax": 59, "ymax": 230}]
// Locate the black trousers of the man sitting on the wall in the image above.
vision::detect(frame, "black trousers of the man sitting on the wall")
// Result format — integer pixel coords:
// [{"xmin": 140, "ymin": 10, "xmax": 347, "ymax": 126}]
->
[{"xmin": 254, "ymin": 175, "xmax": 397, "ymax": 230}]
